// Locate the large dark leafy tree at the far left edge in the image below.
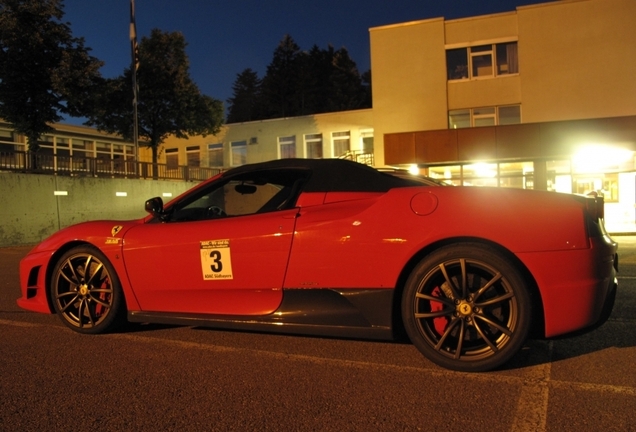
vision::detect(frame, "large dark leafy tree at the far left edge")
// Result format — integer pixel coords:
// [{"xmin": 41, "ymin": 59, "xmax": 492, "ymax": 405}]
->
[{"xmin": 0, "ymin": 0, "xmax": 102, "ymax": 152}]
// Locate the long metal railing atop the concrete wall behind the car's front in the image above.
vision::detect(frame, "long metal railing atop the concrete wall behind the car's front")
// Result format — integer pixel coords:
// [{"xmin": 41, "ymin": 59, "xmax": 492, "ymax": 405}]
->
[{"xmin": 0, "ymin": 151, "xmax": 222, "ymax": 181}]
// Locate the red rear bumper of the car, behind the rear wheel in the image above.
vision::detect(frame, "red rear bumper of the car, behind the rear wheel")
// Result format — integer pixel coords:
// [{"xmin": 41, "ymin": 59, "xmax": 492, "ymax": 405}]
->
[{"xmin": 518, "ymin": 235, "xmax": 618, "ymax": 337}]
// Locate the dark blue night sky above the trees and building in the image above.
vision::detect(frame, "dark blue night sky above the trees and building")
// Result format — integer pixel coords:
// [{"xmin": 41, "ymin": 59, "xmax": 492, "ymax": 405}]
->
[{"xmin": 58, "ymin": 0, "xmax": 545, "ymax": 118}]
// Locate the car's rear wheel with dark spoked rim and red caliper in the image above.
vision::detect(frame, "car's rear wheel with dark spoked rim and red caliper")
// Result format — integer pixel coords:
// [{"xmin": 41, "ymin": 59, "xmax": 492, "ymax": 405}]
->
[{"xmin": 402, "ymin": 243, "xmax": 532, "ymax": 372}]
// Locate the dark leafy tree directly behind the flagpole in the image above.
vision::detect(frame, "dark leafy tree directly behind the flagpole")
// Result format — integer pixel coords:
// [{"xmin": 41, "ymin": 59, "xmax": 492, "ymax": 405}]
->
[{"xmin": 87, "ymin": 29, "xmax": 223, "ymax": 164}]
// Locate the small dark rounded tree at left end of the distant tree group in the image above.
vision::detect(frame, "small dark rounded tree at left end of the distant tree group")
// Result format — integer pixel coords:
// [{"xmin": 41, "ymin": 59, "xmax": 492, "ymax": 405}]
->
[{"xmin": 227, "ymin": 68, "xmax": 261, "ymax": 123}]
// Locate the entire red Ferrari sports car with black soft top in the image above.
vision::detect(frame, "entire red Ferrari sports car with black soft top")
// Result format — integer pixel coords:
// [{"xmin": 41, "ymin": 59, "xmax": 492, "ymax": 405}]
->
[{"xmin": 18, "ymin": 159, "xmax": 617, "ymax": 371}]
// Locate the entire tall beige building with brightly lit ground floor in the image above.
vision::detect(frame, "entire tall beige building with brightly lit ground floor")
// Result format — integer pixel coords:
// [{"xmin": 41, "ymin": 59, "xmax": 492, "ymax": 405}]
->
[{"xmin": 370, "ymin": 0, "xmax": 636, "ymax": 231}]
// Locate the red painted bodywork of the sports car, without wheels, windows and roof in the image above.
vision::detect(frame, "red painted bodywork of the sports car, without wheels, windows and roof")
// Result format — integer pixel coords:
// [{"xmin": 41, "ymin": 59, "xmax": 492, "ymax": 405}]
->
[{"xmin": 18, "ymin": 157, "xmax": 617, "ymax": 342}]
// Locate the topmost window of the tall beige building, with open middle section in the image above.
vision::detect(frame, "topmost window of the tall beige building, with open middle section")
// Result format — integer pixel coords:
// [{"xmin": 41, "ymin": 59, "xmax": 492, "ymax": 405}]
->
[{"xmin": 446, "ymin": 42, "xmax": 519, "ymax": 81}]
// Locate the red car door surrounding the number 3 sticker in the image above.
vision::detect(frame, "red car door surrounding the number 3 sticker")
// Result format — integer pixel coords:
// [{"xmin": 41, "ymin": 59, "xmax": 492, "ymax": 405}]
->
[{"xmin": 123, "ymin": 209, "xmax": 298, "ymax": 315}]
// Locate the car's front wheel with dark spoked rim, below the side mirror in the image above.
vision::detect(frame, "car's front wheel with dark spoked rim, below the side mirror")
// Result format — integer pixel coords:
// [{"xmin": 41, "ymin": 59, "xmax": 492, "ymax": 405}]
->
[{"xmin": 50, "ymin": 245, "xmax": 126, "ymax": 334}]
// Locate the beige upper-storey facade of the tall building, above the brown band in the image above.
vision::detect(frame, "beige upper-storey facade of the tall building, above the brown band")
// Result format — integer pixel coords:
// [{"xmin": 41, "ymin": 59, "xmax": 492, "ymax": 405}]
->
[{"xmin": 370, "ymin": 0, "xmax": 636, "ymax": 164}]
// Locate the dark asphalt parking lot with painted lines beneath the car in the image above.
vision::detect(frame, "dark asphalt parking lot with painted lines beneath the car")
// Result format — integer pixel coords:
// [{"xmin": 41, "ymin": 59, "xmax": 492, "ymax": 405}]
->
[{"xmin": 0, "ymin": 241, "xmax": 636, "ymax": 432}]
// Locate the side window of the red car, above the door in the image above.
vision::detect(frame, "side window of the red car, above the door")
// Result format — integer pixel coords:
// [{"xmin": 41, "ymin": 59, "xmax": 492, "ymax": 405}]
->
[{"xmin": 168, "ymin": 170, "xmax": 308, "ymax": 222}]
